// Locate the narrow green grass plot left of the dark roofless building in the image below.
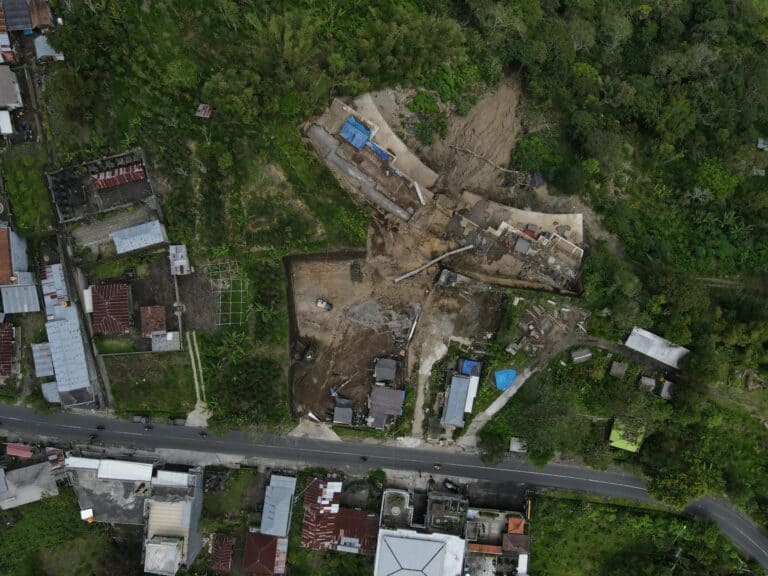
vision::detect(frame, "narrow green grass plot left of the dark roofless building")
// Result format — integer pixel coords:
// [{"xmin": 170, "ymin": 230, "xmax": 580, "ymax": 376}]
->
[{"xmin": 3, "ymin": 144, "xmax": 56, "ymax": 236}]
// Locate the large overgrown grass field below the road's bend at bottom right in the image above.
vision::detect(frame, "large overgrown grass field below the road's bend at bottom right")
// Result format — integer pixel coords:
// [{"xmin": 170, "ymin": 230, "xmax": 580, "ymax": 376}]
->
[{"xmin": 530, "ymin": 496, "xmax": 760, "ymax": 576}]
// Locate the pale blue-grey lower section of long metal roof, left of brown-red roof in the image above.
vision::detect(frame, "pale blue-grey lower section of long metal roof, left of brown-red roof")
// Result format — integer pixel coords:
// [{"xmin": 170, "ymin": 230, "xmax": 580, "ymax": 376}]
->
[{"xmin": 45, "ymin": 308, "xmax": 90, "ymax": 393}]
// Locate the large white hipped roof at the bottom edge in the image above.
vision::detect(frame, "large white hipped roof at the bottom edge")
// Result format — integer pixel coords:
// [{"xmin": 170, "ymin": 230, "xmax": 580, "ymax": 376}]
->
[{"xmin": 373, "ymin": 529, "xmax": 465, "ymax": 576}]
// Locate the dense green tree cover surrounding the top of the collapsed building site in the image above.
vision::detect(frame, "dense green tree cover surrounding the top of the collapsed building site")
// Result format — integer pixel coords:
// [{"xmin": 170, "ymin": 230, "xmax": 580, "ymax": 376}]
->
[{"xmin": 45, "ymin": 0, "xmax": 768, "ymax": 522}]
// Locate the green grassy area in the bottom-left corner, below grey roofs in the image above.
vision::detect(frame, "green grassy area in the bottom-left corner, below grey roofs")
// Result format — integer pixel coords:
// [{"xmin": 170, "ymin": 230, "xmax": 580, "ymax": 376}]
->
[{"xmin": 0, "ymin": 488, "xmax": 100, "ymax": 576}]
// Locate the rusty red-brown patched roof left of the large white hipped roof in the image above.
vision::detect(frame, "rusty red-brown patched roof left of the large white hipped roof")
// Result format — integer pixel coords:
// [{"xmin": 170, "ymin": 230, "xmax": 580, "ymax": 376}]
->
[{"xmin": 301, "ymin": 478, "xmax": 379, "ymax": 556}]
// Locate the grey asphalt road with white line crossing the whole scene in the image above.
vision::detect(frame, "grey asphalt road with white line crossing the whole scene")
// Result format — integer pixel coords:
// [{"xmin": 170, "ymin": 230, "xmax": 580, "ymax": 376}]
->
[{"xmin": 0, "ymin": 405, "xmax": 768, "ymax": 568}]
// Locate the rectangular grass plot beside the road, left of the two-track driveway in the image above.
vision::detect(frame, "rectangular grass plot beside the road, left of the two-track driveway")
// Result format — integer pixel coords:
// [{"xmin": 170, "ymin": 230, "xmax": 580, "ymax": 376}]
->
[{"xmin": 103, "ymin": 352, "xmax": 196, "ymax": 416}]
